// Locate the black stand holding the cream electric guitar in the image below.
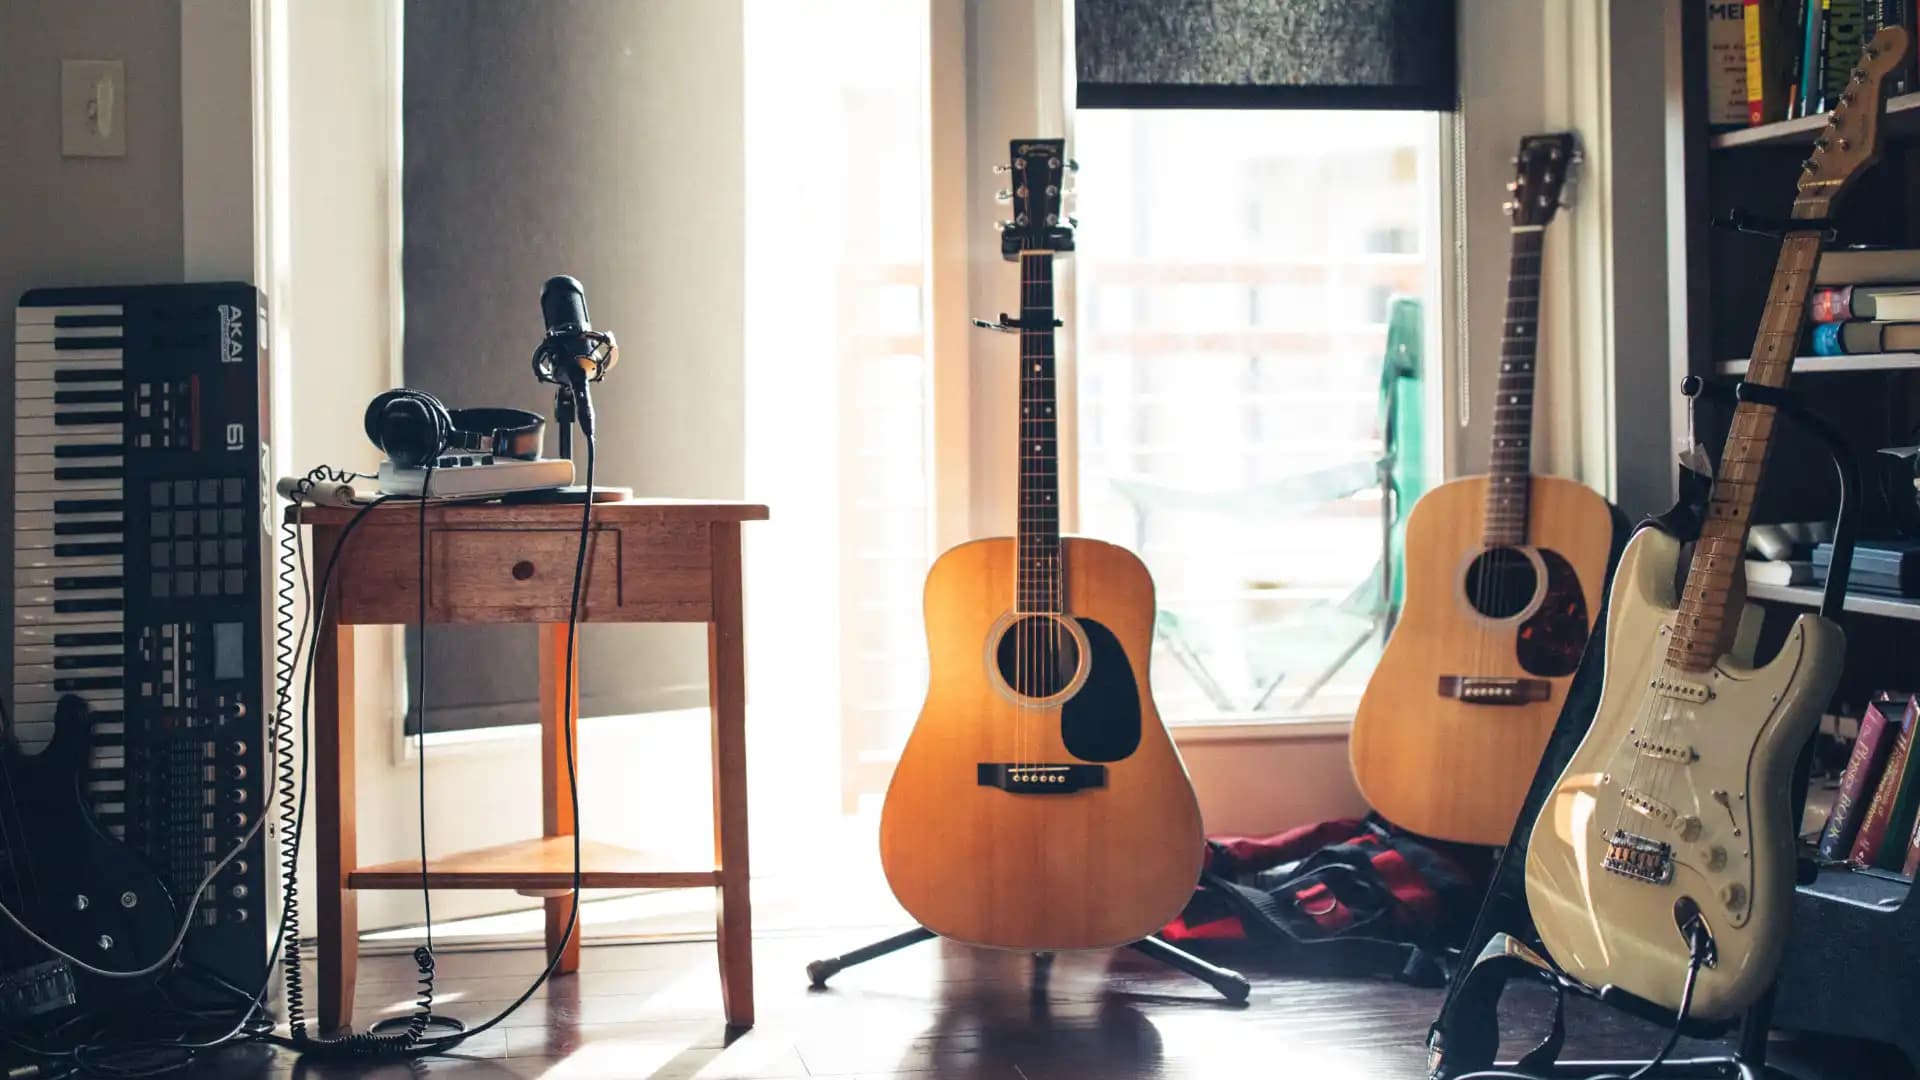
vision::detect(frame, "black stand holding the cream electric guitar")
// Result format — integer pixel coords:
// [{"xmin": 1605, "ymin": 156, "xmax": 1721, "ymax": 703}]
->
[{"xmin": 1427, "ymin": 375, "xmax": 1860, "ymax": 1080}]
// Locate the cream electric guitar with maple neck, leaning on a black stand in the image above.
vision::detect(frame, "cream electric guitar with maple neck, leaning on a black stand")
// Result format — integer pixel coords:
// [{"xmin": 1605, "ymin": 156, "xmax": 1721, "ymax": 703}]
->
[{"xmin": 1526, "ymin": 27, "xmax": 1907, "ymax": 1019}]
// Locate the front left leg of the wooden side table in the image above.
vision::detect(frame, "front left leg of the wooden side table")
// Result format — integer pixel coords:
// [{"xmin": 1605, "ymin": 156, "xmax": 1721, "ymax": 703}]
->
[{"xmin": 313, "ymin": 611, "xmax": 359, "ymax": 1032}]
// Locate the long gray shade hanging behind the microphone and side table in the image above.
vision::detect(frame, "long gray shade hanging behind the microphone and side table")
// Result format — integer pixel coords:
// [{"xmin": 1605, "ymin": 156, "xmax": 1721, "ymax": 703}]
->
[{"xmin": 403, "ymin": 0, "xmax": 745, "ymax": 726}]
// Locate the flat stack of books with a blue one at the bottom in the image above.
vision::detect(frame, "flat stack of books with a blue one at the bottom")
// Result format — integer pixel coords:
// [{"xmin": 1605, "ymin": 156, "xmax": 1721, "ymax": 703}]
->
[{"xmin": 1807, "ymin": 248, "xmax": 1920, "ymax": 356}]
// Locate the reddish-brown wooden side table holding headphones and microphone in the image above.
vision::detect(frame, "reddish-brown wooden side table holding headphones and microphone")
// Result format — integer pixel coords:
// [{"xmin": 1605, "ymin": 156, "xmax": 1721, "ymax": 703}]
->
[{"xmin": 288, "ymin": 500, "xmax": 766, "ymax": 1032}]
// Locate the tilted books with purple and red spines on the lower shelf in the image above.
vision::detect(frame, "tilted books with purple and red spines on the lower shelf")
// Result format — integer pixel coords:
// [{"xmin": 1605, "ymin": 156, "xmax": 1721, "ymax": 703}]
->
[{"xmin": 1818, "ymin": 694, "xmax": 1920, "ymax": 878}]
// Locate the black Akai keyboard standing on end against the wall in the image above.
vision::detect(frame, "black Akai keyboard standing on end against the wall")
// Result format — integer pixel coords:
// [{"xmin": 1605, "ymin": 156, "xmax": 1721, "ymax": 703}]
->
[{"xmin": 12, "ymin": 282, "xmax": 271, "ymax": 986}]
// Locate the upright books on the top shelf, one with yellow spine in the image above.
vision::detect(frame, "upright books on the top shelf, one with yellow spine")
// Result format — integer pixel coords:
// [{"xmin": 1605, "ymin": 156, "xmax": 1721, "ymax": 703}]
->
[{"xmin": 1720, "ymin": 0, "xmax": 1920, "ymax": 127}]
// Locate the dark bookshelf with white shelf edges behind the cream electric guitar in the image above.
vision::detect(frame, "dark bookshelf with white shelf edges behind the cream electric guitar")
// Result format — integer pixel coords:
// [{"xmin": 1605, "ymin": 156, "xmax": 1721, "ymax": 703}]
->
[{"xmin": 1667, "ymin": 0, "xmax": 1920, "ymax": 1065}]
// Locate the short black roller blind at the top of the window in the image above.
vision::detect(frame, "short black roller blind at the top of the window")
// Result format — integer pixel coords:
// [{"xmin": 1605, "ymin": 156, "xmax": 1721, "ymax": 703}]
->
[{"xmin": 1073, "ymin": 0, "xmax": 1457, "ymax": 111}]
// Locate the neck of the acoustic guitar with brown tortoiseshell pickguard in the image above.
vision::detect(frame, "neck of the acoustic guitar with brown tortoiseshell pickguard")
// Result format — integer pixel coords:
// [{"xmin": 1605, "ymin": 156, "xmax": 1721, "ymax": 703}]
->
[{"xmin": 1484, "ymin": 225, "xmax": 1546, "ymax": 548}]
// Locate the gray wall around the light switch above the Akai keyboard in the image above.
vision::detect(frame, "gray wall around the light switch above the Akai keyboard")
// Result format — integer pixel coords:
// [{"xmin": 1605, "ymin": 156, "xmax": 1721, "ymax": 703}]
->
[{"xmin": 0, "ymin": 0, "xmax": 182, "ymax": 686}]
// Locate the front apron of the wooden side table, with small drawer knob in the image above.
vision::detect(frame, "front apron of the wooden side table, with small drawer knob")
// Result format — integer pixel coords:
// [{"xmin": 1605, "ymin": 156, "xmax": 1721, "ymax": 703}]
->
[{"xmin": 326, "ymin": 523, "xmax": 712, "ymax": 623}]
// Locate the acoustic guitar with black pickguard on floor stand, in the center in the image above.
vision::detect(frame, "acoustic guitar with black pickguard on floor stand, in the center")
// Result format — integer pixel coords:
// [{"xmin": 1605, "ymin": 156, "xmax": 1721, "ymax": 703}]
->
[{"xmin": 879, "ymin": 138, "xmax": 1204, "ymax": 951}]
